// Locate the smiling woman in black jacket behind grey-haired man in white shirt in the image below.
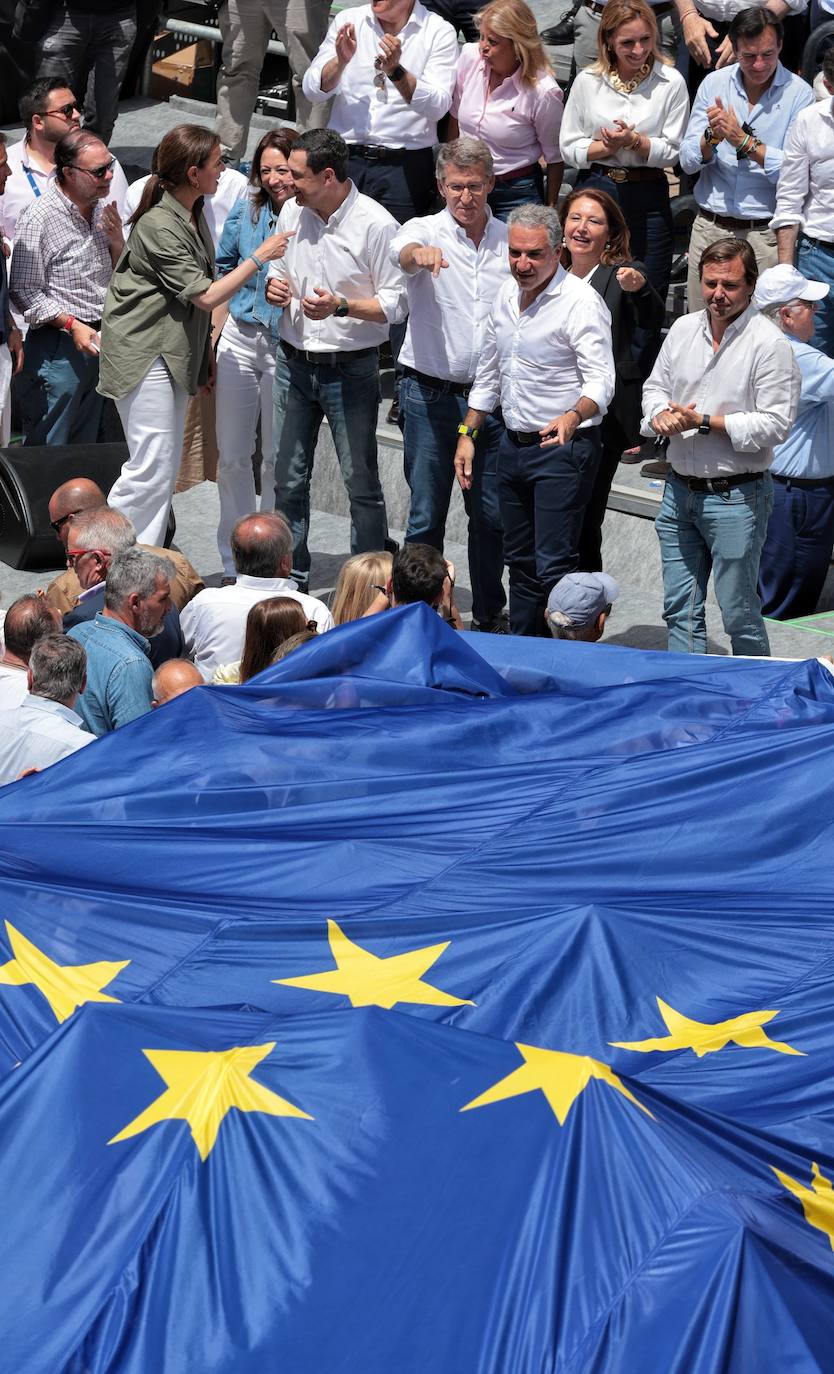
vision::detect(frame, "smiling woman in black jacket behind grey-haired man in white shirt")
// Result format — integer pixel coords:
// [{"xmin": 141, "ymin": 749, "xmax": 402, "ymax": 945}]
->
[{"xmin": 559, "ymin": 187, "xmax": 665, "ymax": 573}]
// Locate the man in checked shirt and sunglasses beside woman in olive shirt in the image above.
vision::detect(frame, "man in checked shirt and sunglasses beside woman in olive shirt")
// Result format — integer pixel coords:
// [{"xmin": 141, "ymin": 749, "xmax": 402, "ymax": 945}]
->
[{"xmin": 10, "ymin": 129, "xmax": 124, "ymax": 444}]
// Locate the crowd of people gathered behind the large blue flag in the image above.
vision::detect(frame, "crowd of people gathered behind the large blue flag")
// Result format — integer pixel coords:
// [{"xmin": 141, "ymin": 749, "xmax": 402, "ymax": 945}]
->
[{"xmin": 0, "ymin": 0, "xmax": 834, "ymax": 780}]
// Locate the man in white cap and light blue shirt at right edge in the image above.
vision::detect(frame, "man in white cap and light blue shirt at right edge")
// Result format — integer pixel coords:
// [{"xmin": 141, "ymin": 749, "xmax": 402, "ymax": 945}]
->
[{"xmin": 753, "ymin": 262, "xmax": 834, "ymax": 620}]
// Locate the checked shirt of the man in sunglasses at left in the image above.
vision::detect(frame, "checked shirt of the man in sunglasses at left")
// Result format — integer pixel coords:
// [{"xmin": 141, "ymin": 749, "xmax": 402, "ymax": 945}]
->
[{"xmin": 10, "ymin": 184, "xmax": 113, "ymax": 328}]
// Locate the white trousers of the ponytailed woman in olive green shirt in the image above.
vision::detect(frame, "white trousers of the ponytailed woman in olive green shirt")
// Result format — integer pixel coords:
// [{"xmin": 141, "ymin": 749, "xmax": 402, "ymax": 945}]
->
[{"xmin": 107, "ymin": 357, "xmax": 188, "ymax": 548}]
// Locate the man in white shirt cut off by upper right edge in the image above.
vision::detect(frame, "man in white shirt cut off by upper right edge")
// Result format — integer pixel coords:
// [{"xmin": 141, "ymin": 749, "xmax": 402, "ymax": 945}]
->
[{"xmin": 771, "ymin": 48, "xmax": 834, "ymax": 357}]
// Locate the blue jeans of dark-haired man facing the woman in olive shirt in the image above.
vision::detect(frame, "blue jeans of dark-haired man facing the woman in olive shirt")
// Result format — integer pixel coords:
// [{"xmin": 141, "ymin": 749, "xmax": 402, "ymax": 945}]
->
[{"xmin": 273, "ymin": 344, "xmax": 387, "ymax": 585}]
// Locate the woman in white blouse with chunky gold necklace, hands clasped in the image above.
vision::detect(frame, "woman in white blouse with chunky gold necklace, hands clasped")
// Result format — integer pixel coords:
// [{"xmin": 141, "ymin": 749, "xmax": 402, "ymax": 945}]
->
[{"xmin": 559, "ymin": 0, "xmax": 690, "ymax": 350}]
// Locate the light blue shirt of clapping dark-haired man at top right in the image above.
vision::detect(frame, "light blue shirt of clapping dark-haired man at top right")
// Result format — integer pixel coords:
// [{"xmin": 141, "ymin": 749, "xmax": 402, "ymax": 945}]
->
[{"xmin": 680, "ymin": 62, "xmax": 815, "ymax": 220}]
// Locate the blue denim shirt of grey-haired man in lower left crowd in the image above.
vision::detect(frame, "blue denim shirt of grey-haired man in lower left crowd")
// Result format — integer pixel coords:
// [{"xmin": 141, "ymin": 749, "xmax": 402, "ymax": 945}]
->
[{"xmin": 67, "ymin": 611, "xmax": 154, "ymax": 735}]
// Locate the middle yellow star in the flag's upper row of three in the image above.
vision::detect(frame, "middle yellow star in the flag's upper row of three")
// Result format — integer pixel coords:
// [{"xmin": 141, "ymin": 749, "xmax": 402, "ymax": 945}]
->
[{"xmin": 272, "ymin": 921, "xmax": 475, "ymax": 1011}]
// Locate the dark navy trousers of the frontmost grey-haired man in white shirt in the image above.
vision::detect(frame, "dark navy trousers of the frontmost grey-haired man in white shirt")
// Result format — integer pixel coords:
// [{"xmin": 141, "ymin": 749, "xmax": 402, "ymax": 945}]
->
[{"xmin": 497, "ymin": 425, "xmax": 600, "ymax": 635}]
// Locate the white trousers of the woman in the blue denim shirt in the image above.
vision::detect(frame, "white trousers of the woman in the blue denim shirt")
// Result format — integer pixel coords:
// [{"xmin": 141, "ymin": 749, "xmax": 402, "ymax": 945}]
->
[{"xmin": 217, "ymin": 315, "xmax": 275, "ymax": 577}]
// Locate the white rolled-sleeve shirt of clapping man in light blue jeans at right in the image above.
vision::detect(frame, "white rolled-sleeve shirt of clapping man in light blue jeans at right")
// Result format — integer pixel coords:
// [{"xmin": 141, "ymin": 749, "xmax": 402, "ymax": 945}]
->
[{"xmin": 642, "ymin": 305, "xmax": 800, "ymax": 477}]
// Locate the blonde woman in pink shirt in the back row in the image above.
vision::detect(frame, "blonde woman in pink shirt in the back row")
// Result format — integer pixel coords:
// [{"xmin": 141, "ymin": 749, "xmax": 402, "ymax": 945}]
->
[{"xmin": 449, "ymin": 0, "xmax": 563, "ymax": 220}]
